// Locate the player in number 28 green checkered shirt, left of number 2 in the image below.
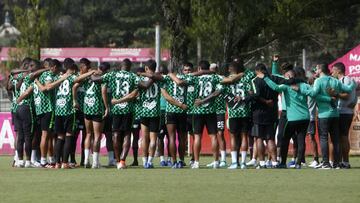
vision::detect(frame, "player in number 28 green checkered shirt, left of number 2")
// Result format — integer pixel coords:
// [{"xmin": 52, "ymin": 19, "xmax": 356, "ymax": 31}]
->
[{"xmin": 36, "ymin": 58, "xmax": 76, "ymax": 169}]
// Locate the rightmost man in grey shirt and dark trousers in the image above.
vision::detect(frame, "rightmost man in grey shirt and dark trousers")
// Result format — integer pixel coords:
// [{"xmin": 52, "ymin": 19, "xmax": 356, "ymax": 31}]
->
[{"xmin": 332, "ymin": 62, "xmax": 357, "ymax": 169}]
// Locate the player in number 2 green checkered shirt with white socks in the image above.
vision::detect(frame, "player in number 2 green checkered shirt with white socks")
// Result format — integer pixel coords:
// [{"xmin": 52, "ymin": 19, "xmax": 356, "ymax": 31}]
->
[{"xmin": 74, "ymin": 61, "xmax": 109, "ymax": 169}]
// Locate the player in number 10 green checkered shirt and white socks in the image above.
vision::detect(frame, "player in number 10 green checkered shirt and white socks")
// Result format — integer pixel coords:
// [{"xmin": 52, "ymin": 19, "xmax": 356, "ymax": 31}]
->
[{"xmin": 138, "ymin": 60, "xmax": 162, "ymax": 169}]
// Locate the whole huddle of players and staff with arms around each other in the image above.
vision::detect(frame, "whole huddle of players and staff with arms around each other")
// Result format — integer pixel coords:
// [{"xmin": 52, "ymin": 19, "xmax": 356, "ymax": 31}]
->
[{"xmin": 7, "ymin": 56, "xmax": 356, "ymax": 169}]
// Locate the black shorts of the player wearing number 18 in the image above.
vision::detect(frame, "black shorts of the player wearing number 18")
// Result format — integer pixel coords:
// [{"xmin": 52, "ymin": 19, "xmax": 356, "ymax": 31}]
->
[{"xmin": 193, "ymin": 113, "xmax": 217, "ymax": 134}]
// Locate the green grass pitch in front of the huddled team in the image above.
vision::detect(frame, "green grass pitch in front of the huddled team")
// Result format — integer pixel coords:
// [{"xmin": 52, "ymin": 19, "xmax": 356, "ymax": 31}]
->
[{"xmin": 0, "ymin": 156, "xmax": 360, "ymax": 203}]
